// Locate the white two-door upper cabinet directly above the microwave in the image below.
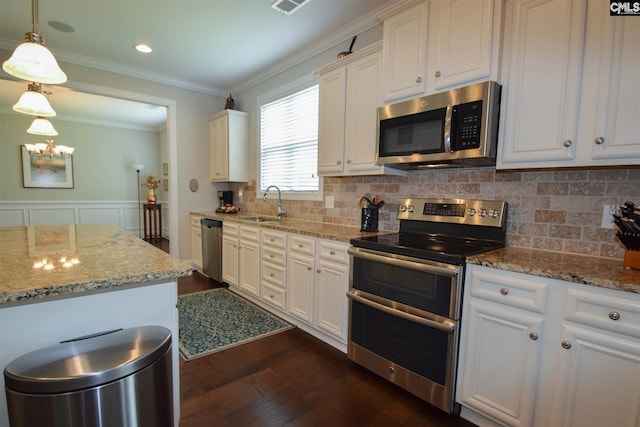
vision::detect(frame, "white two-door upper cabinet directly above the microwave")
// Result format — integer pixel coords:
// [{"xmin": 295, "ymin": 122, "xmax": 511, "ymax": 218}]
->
[{"xmin": 378, "ymin": 0, "xmax": 502, "ymax": 103}]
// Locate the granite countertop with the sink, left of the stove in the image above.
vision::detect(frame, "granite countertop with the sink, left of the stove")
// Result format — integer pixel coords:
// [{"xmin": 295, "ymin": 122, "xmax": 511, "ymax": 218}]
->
[{"xmin": 192, "ymin": 212, "xmax": 384, "ymax": 242}]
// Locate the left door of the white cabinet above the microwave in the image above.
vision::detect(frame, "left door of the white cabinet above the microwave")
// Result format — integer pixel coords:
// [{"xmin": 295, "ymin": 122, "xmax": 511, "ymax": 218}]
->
[{"xmin": 382, "ymin": 1, "xmax": 429, "ymax": 103}]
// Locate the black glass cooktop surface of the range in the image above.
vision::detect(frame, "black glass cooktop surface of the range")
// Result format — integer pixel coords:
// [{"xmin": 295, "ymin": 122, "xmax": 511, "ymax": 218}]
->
[{"xmin": 351, "ymin": 233, "xmax": 504, "ymax": 265}]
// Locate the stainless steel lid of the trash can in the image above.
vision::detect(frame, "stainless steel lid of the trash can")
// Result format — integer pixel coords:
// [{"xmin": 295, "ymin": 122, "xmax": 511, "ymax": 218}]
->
[{"xmin": 4, "ymin": 326, "xmax": 171, "ymax": 394}]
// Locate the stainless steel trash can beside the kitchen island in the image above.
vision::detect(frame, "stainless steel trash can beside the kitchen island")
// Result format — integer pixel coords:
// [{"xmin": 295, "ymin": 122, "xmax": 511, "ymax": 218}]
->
[{"xmin": 4, "ymin": 326, "xmax": 173, "ymax": 427}]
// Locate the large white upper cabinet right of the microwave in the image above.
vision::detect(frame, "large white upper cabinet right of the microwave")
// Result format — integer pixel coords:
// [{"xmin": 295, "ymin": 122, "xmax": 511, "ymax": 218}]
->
[{"xmin": 497, "ymin": 0, "xmax": 640, "ymax": 169}]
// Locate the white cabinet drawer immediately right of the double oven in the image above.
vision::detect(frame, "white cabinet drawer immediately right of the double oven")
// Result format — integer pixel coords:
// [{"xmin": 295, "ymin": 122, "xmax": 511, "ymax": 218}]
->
[{"xmin": 469, "ymin": 266, "xmax": 549, "ymax": 313}]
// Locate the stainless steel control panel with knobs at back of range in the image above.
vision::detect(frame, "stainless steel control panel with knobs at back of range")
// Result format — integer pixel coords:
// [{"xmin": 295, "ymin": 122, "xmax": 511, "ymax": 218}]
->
[{"xmin": 396, "ymin": 199, "xmax": 507, "ymax": 227}]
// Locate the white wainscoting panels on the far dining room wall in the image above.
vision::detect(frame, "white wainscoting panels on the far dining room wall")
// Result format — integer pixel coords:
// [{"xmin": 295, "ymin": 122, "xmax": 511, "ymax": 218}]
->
[{"xmin": 0, "ymin": 201, "xmax": 169, "ymax": 237}]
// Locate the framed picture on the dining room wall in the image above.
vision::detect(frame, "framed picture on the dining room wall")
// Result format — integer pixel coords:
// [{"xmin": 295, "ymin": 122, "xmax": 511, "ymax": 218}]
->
[{"xmin": 20, "ymin": 145, "xmax": 73, "ymax": 188}]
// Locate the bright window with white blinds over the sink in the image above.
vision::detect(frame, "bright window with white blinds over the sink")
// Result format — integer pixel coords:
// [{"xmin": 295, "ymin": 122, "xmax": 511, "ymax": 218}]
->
[{"xmin": 258, "ymin": 78, "xmax": 322, "ymax": 200}]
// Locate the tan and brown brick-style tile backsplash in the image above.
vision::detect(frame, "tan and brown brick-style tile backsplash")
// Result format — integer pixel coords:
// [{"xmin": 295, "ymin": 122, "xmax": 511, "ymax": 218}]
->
[{"xmin": 231, "ymin": 168, "xmax": 640, "ymax": 258}]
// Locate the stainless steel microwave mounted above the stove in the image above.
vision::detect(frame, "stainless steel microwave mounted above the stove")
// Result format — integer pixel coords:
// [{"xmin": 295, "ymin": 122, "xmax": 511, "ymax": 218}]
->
[{"xmin": 376, "ymin": 81, "xmax": 502, "ymax": 169}]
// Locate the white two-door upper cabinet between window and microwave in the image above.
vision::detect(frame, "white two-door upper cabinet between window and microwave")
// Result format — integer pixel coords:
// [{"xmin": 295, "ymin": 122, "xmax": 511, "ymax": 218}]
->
[{"xmin": 317, "ymin": 43, "xmax": 403, "ymax": 176}]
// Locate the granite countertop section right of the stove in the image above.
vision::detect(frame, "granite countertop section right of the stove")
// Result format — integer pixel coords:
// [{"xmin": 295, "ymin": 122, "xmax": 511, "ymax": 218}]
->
[{"xmin": 467, "ymin": 247, "xmax": 640, "ymax": 294}]
